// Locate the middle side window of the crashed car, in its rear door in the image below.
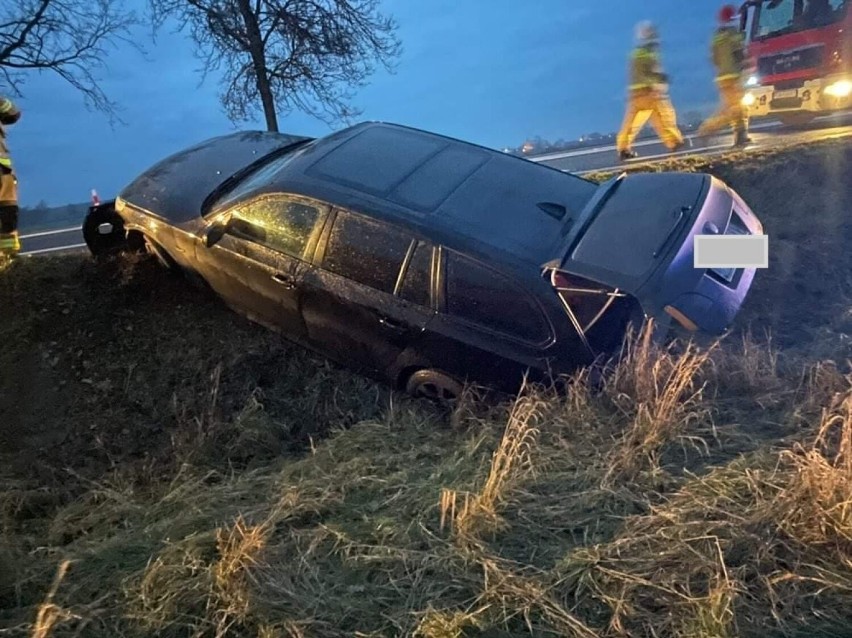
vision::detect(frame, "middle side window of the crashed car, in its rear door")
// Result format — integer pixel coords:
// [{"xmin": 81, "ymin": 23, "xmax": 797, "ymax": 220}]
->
[{"xmin": 323, "ymin": 211, "xmax": 411, "ymax": 294}]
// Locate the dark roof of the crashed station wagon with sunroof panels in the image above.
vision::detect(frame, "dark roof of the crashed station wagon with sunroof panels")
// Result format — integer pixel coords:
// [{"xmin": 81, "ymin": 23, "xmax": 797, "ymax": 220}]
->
[{"xmin": 262, "ymin": 122, "xmax": 597, "ymax": 267}]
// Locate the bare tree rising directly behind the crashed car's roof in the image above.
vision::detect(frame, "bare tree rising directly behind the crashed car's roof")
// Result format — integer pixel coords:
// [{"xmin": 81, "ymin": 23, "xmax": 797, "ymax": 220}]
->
[{"xmin": 149, "ymin": 0, "xmax": 401, "ymax": 131}]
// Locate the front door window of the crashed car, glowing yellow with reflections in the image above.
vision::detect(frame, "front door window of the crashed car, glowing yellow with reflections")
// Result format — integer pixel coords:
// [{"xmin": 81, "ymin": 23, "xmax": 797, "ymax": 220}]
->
[{"xmin": 228, "ymin": 197, "xmax": 320, "ymax": 258}]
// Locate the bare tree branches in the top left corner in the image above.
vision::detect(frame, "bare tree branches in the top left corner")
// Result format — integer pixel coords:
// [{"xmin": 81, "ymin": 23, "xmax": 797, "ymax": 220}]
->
[{"xmin": 0, "ymin": 0, "xmax": 136, "ymax": 116}]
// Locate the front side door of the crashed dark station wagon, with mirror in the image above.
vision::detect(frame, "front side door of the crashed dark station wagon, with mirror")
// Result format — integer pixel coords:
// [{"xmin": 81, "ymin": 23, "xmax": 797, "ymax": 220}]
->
[{"xmin": 197, "ymin": 194, "xmax": 328, "ymax": 341}]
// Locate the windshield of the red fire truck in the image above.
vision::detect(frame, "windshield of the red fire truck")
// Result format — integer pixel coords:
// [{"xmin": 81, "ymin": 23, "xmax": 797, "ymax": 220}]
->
[{"xmin": 752, "ymin": 0, "xmax": 849, "ymax": 40}]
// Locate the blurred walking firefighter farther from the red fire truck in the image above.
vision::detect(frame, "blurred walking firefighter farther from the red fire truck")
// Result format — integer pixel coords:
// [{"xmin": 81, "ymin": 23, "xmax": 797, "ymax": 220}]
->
[{"xmin": 616, "ymin": 22, "xmax": 684, "ymax": 160}]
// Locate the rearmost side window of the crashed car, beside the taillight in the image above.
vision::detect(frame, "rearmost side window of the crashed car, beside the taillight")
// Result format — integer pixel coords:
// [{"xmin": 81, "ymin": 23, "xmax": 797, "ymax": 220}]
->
[{"xmin": 447, "ymin": 251, "xmax": 550, "ymax": 343}]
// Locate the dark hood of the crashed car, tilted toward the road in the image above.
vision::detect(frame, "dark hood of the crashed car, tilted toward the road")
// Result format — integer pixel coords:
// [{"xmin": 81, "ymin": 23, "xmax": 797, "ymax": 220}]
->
[{"xmin": 118, "ymin": 131, "xmax": 311, "ymax": 224}]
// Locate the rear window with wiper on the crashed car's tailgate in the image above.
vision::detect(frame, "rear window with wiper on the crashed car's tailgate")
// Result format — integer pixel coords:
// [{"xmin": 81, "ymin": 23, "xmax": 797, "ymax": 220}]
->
[{"xmin": 543, "ymin": 173, "xmax": 712, "ymax": 308}]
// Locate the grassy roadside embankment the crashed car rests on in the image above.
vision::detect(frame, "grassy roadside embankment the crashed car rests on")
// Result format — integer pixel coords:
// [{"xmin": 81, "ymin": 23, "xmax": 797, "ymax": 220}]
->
[{"xmin": 0, "ymin": 142, "xmax": 852, "ymax": 638}]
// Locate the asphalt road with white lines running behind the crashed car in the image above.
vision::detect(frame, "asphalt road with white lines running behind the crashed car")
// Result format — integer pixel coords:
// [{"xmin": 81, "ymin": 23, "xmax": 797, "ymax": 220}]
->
[{"xmin": 16, "ymin": 113, "xmax": 852, "ymax": 255}]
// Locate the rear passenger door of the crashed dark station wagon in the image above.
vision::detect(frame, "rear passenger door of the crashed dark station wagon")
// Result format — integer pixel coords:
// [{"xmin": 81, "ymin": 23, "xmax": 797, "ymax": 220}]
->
[{"xmin": 302, "ymin": 210, "xmax": 434, "ymax": 380}]
